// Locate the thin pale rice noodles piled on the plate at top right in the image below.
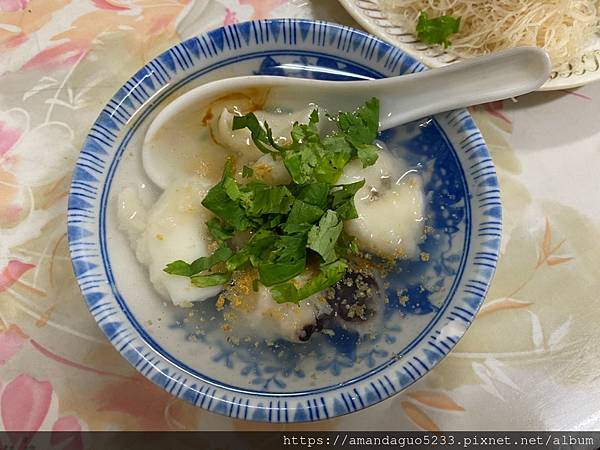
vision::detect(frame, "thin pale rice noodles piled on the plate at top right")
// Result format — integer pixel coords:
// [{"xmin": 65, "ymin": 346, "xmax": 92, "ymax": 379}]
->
[{"xmin": 380, "ymin": 0, "xmax": 600, "ymax": 68}]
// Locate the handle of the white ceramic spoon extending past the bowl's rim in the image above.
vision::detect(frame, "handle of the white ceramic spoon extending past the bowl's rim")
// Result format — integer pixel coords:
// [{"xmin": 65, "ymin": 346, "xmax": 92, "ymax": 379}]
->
[{"xmin": 338, "ymin": 47, "xmax": 552, "ymax": 130}]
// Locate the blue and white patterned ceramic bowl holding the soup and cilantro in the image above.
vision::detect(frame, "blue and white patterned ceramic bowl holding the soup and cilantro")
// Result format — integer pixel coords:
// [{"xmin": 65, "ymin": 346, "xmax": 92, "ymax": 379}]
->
[{"xmin": 68, "ymin": 20, "xmax": 501, "ymax": 422}]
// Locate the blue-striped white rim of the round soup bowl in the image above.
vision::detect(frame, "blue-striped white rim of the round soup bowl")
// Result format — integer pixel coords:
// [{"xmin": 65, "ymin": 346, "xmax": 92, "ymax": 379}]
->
[{"xmin": 67, "ymin": 19, "xmax": 502, "ymax": 422}]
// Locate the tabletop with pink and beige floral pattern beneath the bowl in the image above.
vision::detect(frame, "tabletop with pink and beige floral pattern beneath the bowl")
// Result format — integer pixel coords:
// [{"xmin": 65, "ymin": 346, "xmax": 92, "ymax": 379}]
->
[{"xmin": 0, "ymin": 0, "xmax": 600, "ymax": 430}]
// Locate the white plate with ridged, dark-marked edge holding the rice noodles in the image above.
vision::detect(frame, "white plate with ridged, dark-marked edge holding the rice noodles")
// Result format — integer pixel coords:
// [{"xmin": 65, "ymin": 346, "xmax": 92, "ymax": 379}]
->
[{"xmin": 339, "ymin": 0, "xmax": 600, "ymax": 91}]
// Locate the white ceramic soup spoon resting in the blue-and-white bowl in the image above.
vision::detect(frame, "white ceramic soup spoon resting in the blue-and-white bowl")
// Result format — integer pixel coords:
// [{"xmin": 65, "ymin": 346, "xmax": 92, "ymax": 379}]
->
[{"xmin": 142, "ymin": 47, "xmax": 552, "ymax": 189}]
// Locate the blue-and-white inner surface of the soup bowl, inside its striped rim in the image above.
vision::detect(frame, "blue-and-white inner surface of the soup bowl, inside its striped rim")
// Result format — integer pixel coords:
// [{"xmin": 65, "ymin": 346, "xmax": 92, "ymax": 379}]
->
[{"xmin": 104, "ymin": 54, "xmax": 467, "ymax": 392}]
